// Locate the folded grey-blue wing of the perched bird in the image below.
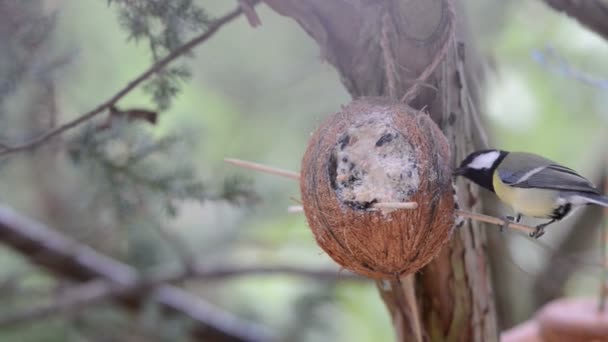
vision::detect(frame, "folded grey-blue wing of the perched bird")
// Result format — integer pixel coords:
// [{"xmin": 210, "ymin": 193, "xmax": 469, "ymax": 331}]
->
[{"xmin": 499, "ymin": 164, "xmax": 599, "ymax": 194}]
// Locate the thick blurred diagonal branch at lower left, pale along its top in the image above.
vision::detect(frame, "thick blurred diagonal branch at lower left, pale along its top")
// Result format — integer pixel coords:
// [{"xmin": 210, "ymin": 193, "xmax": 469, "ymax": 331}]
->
[{"xmin": 0, "ymin": 207, "xmax": 274, "ymax": 341}]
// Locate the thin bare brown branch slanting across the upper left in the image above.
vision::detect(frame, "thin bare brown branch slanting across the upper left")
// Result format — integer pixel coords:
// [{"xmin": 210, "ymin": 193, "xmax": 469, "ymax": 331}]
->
[{"xmin": 0, "ymin": 0, "xmax": 260, "ymax": 156}]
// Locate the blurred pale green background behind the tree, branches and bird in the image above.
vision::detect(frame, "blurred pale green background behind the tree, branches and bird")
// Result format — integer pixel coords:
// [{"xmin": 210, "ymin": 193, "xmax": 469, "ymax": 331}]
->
[{"xmin": 0, "ymin": 0, "xmax": 608, "ymax": 342}]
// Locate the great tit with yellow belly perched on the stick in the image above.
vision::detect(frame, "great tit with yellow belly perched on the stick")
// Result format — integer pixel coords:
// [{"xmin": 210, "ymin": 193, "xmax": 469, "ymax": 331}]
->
[{"xmin": 454, "ymin": 150, "xmax": 608, "ymax": 238}]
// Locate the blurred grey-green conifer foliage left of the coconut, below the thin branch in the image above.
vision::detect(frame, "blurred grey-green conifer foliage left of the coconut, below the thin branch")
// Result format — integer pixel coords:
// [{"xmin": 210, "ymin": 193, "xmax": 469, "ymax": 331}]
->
[{"xmin": 69, "ymin": 120, "xmax": 256, "ymax": 220}]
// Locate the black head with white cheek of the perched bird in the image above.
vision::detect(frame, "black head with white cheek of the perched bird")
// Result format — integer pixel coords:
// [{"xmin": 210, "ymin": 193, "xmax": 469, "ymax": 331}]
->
[{"xmin": 454, "ymin": 150, "xmax": 509, "ymax": 192}]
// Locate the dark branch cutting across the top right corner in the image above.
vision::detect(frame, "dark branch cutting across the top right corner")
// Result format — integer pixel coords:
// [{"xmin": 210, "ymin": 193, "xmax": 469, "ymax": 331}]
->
[{"xmin": 545, "ymin": 0, "xmax": 608, "ymax": 39}]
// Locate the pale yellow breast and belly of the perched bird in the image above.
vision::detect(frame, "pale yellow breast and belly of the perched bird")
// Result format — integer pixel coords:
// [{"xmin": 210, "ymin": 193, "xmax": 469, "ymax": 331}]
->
[{"xmin": 492, "ymin": 172, "xmax": 558, "ymax": 218}]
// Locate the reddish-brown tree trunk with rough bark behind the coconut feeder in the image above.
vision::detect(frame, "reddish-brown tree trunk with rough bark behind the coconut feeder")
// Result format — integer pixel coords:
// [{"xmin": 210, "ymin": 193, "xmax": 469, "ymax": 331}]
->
[{"xmin": 265, "ymin": 0, "xmax": 498, "ymax": 342}]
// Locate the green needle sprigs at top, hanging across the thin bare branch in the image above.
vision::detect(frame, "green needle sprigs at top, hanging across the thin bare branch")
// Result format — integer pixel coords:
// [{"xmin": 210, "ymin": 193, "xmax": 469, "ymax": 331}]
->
[{"xmin": 107, "ymin": 0, "xmax": 210, "ymax": 110}]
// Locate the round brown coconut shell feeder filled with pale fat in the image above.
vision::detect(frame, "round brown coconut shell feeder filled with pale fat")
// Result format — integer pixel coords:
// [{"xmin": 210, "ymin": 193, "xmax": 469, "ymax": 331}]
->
[{"xmin": 300, "ymin": 98, "xmax": 455, "ymax": 278}]
